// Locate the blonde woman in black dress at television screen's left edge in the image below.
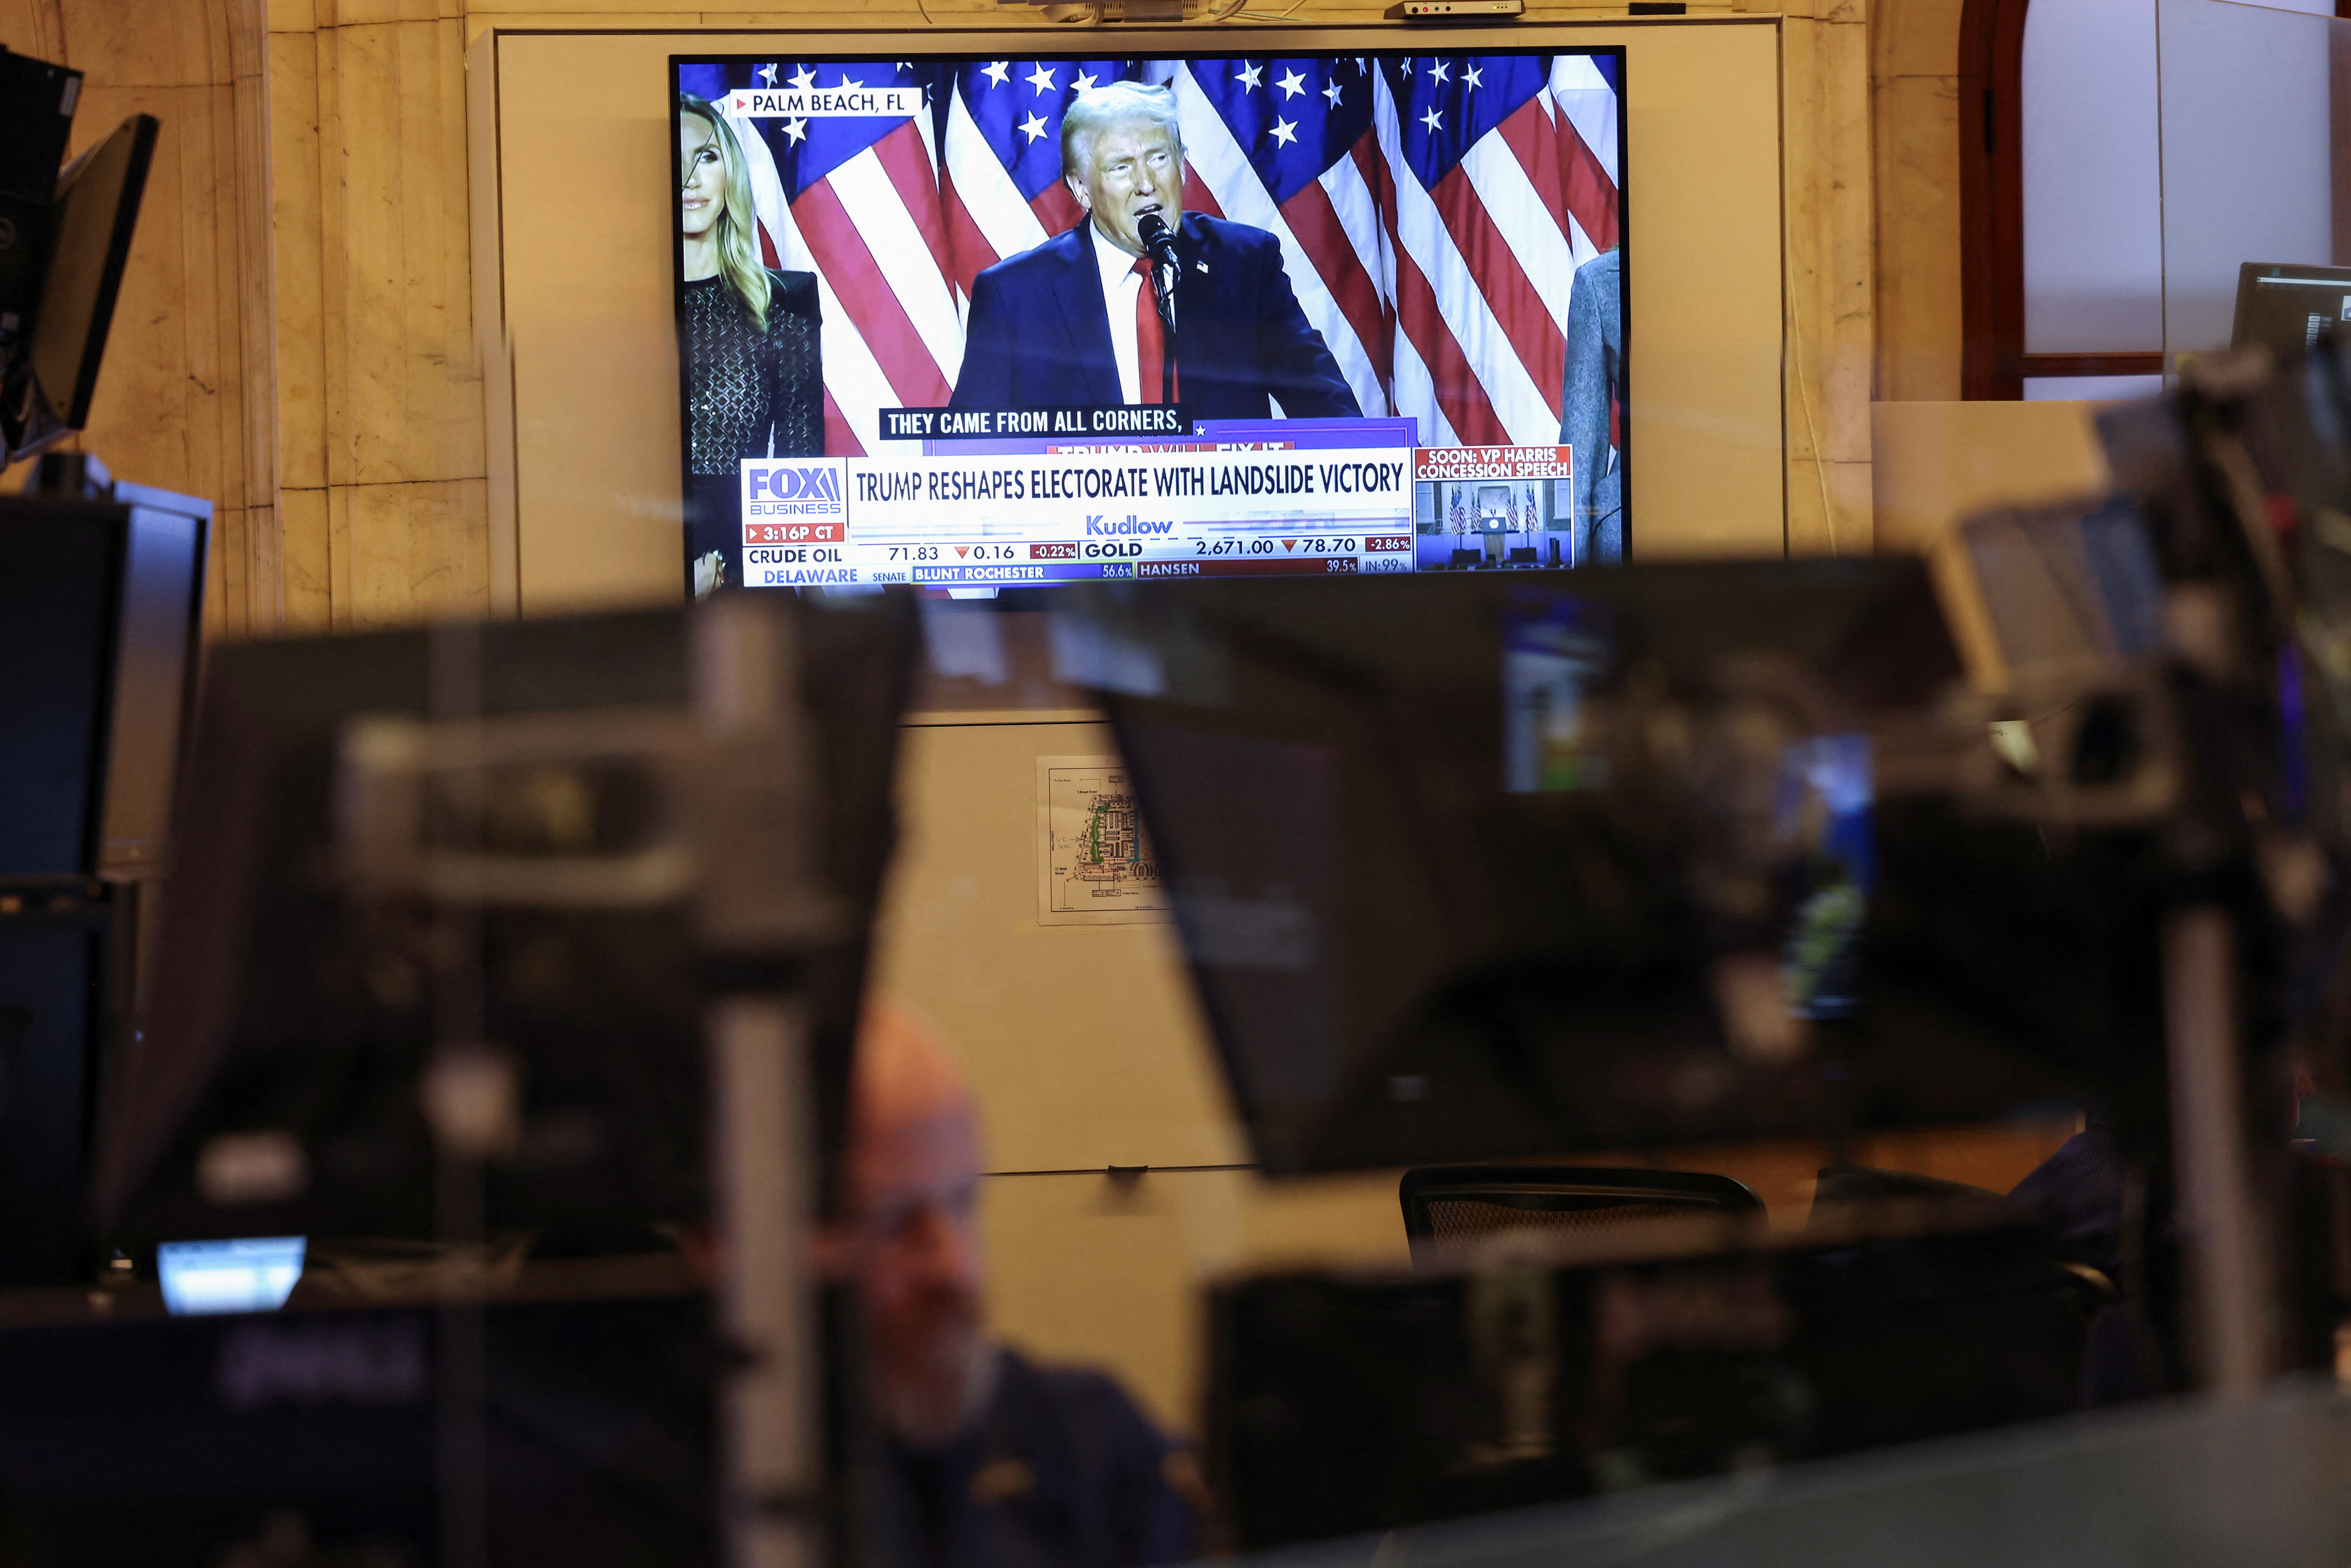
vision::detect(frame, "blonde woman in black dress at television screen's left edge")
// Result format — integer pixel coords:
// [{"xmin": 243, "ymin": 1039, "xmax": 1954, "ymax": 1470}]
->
[{"xmin": 677, "ymin": 94, "xmax": 825, "ymax": 597}]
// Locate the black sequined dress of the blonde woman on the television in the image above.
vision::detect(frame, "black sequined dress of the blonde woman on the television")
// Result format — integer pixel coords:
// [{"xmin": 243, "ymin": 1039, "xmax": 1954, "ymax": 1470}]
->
[{"xmin": 677, "ymin": 270, "xmax": 825, "ymax": 590}]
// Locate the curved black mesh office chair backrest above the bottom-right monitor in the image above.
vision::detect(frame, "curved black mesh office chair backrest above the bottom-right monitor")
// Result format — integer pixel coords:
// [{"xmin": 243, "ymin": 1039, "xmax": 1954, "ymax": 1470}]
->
[{"xmin": 1396, "ymin": 1164, "xmax": 1763, "ymax": 1267}]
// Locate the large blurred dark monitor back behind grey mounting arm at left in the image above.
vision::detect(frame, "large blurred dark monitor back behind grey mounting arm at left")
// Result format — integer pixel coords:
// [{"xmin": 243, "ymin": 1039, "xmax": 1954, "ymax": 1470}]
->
[{"xmin": 94, "ymin": 595, "xmax": 915, "ymax": 1251}]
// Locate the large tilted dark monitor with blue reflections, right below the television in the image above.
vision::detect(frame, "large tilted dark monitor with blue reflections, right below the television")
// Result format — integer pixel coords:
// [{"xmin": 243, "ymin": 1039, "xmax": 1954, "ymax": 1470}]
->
[{"xmin": 1058, "ymin": 559, "xmax": 2121, "ymax": 1173}]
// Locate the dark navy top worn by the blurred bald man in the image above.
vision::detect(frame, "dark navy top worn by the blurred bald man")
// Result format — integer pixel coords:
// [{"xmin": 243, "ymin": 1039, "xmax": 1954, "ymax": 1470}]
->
[{"xmin": 865, "ymin": 1349, "xmax": 1197, "ymax": 1568}]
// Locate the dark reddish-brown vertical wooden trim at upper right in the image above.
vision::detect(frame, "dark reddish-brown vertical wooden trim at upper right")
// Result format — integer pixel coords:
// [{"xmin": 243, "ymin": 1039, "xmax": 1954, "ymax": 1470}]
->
[{"xmin": 1958, "ymin": 0, "xmax": 2027, "ymax": 402}]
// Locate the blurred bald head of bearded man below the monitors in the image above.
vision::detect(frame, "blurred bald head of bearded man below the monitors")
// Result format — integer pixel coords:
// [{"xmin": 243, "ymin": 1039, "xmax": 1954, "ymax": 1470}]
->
[{"xmin": 842, "ymin": 1004, "xmax": 994, "ymax": 1446}]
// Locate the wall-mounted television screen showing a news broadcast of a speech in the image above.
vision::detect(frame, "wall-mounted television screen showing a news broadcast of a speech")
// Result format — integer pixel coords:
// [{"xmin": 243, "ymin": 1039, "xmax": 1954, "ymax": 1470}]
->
[{"xmin": 670, "ymin": 49, "xmax": 1627, "ymax": 597}]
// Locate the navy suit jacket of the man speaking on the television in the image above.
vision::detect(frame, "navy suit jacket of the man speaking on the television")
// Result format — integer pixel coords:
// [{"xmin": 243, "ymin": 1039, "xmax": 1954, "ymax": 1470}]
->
[{"xmin": 952, "ymin": 212, "xmax": 1364, "ymax": 418}]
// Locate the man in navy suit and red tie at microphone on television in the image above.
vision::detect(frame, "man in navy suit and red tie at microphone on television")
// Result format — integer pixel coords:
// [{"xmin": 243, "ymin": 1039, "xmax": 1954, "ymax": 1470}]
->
[{"xmin": 952, "ymin": 82, "xmax": 1364, "ymax": 418}]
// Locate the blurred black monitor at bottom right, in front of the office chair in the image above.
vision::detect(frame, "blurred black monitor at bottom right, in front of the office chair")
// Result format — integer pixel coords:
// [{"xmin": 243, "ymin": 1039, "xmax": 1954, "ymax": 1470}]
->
[{"xmin": 1201, "ymin": 1220, "xmax": 2090, "ymax": 1563}]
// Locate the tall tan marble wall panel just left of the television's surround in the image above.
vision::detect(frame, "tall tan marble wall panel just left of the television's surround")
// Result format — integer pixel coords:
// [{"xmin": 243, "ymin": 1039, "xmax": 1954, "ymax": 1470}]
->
[{"xmin": 268, "ymin": 0, "xmax": 489, "ymax": 628}]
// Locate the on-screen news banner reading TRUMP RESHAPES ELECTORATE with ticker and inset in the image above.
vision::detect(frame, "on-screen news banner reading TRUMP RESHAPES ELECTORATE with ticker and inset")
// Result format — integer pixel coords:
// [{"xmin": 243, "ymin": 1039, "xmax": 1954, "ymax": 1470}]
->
[{"xmin": 743, "ymin": 433, "xmax": 1575, "ymax": 588}]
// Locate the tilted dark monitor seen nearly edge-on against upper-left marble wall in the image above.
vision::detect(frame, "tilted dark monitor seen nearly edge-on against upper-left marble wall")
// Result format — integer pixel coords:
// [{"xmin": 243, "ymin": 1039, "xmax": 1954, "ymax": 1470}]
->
[{"xmin": 12, "ymin": 115, "xmax": 158, "ymax": 458}]
